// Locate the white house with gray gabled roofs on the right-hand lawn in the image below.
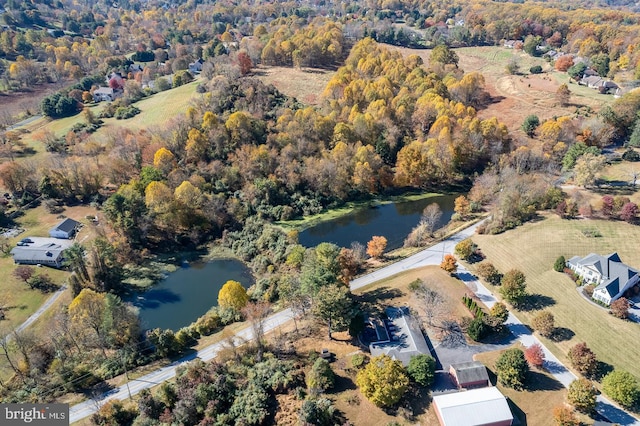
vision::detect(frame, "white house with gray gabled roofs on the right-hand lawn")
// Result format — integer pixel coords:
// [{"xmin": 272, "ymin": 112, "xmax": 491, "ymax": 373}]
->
[{"xmin": 567, "ymin": 253, "xmax": 640, "ymax": 305}]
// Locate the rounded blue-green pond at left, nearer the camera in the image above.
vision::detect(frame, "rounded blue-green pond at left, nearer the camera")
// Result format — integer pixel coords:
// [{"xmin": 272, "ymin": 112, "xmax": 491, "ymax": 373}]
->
[{"xmin": 128, "ymin": 259, "xmax": 253, "ymax": 331}]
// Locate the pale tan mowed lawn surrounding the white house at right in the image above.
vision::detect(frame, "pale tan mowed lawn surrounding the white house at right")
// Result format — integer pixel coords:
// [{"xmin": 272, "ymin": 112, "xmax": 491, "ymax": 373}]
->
[{"xmin": 471, "ymin": 214, "xmax": 640, "ymax": 378}]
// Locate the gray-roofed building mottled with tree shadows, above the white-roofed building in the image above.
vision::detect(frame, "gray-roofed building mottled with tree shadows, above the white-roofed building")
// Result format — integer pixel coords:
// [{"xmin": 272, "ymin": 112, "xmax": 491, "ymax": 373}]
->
[{"xmin": 369, "ymin": 307, "xmax": 431, "ymax": 367}]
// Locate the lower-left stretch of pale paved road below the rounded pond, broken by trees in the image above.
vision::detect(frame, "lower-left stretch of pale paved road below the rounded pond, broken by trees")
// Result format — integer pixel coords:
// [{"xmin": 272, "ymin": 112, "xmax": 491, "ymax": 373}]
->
[{"xmin": 69, "ymin": 309, "xmax": 292, "ymax": 423}]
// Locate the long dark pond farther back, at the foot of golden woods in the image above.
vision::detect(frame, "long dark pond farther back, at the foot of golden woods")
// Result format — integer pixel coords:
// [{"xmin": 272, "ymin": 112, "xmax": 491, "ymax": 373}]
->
[{"xmin": 298, "ymin": 195, "xmax": 458, "ymax": 250}]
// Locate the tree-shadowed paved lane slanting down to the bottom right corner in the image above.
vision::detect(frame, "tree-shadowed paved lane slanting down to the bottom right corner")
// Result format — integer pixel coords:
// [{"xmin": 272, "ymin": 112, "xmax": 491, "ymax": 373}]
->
[{"xmin": 458, "ymin": 266, "xmax": 640, "ymax": 426}]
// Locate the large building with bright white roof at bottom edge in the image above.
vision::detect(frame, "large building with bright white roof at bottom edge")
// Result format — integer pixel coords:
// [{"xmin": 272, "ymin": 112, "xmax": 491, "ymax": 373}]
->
[{"xmin": 433, "ymin": 386, "xmax": 513, "ymax": 426}]
